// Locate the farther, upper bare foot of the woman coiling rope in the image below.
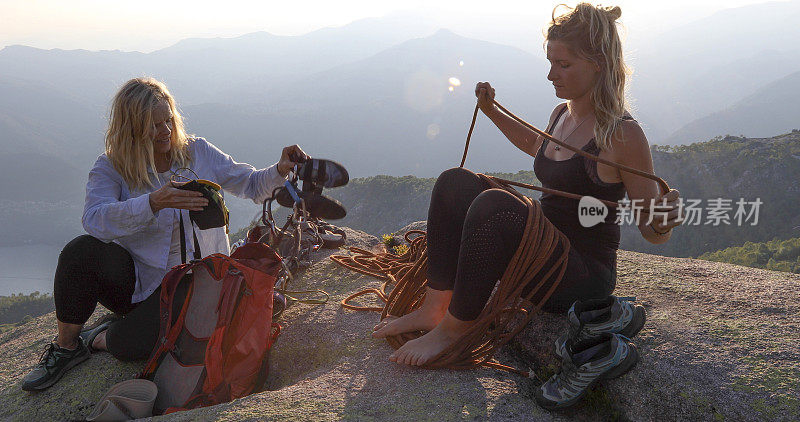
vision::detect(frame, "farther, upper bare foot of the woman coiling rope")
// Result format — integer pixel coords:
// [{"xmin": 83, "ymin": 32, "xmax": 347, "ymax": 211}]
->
[{"xmin": 372, "ymin": 287, "xmax": 453, "ymax": 338}]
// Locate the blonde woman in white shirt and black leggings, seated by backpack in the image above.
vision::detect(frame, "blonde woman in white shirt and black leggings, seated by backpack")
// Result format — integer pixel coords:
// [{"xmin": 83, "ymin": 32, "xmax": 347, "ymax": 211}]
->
[{"xmin": 22, "ymin": 78, "xmax": 308, "ymax": 390}]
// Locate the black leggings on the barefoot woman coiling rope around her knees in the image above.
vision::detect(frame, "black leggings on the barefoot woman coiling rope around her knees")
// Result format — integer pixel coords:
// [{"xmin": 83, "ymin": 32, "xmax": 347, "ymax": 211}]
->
[{"xmin": 427, "ymin": 168, "xmax": 616, "ymax": 321}]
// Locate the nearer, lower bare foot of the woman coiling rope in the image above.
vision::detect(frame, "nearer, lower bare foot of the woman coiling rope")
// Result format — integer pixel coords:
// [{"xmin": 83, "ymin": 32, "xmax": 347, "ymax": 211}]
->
[{"xmin": 389, "ymin": 312, "xmax": 475, "ymax": 366}]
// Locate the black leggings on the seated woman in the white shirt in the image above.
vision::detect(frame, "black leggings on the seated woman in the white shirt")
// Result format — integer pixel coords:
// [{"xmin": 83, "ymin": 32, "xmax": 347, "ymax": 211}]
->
[{"xmin": 53, "ymin": 234, "xmax": 161, "ymax": 360}]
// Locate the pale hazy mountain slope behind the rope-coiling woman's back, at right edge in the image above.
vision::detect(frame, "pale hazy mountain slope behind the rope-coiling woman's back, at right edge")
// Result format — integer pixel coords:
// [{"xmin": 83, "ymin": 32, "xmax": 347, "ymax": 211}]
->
[{"xmin": 629, "ymin": 0, "xmax": 800, "ymax": 143}]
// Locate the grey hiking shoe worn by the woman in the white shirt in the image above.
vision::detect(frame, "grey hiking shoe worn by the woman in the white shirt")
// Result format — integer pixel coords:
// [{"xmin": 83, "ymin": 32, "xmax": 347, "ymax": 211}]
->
[{"xmin": 22, "ymin": 339, "xmax": 90, "ymax": 391}]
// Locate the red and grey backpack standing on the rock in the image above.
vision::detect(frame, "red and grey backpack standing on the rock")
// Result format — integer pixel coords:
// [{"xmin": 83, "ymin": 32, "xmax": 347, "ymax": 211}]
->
[{"xmin": 140, "ymin": 242, "xmax": 281, "ymax": 414}]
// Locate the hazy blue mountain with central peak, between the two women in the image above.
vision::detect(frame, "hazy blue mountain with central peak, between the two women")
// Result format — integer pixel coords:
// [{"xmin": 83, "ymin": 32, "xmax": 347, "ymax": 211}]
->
[{"xmin": 184, "ymin": 30, "xmax": 556, "ymax": 177}]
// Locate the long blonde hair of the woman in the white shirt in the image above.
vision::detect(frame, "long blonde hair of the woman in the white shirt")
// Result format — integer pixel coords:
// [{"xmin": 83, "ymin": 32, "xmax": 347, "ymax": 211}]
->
[{"xmin": 106, "ymin": 78, "xmax": 191, "ymax": 190}]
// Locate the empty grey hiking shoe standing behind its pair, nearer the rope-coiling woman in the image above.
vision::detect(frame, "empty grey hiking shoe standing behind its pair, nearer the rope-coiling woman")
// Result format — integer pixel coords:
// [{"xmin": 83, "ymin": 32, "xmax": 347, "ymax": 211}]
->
[{"xmin": 556, "ymin": 296, "xmax": 647, "ymax": 356}]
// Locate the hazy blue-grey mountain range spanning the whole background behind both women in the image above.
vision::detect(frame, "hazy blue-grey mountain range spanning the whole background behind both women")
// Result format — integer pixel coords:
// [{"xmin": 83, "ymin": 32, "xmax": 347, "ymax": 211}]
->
[{"xmin": 0, "ymin": 1, "xmax": 800, "ymax": 256}]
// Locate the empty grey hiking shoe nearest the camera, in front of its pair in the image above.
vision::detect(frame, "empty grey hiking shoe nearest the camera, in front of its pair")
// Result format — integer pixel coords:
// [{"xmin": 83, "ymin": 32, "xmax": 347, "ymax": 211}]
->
[{"xmin": 536, "ymin": 333, "xmax": 639, "ymax": 410}]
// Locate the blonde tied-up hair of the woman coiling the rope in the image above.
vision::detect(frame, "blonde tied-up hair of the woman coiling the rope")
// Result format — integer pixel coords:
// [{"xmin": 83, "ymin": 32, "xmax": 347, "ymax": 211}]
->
[{"xmin": 545, "ymin": 3, "xmax": 630, "ymax": 150}]
